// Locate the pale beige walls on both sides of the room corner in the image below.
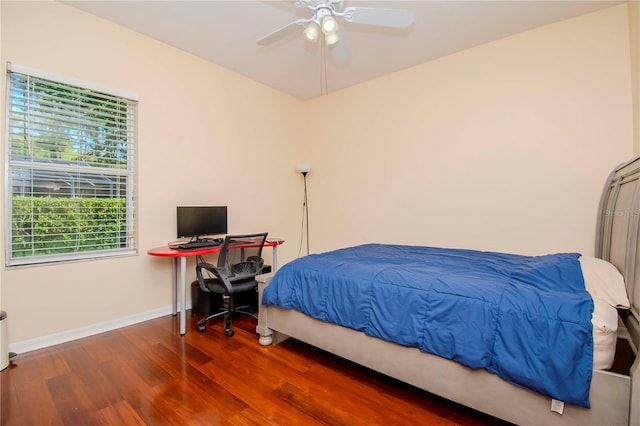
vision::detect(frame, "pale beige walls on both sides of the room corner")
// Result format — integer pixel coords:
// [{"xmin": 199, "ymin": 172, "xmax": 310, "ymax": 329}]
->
[{"xmin": 0, "ymin": 1, "xmax": 633, "ymax": 343}]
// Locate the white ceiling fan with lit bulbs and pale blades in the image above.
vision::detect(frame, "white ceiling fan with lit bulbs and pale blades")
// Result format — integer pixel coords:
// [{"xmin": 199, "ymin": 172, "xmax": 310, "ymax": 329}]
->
[{"xmin": 256, "ymin": 0, "xmax": 414, "ymax": 63}]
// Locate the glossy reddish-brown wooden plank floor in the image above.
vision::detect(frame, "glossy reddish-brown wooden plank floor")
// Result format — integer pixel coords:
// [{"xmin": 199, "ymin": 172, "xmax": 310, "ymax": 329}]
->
[{"xmin": 0, "ymin": 315, "xmax": 510, "ymax": 426}]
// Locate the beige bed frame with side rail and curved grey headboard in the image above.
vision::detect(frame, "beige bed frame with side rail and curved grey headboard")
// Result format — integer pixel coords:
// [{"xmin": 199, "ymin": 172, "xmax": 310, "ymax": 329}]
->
[{"xmin": 256, "ymin": 157, "xmax": 640, "ymax": 425}]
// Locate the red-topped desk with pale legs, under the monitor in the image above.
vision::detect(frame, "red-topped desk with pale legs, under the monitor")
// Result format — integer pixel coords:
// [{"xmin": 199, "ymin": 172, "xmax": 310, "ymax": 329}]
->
[{"xmin": 147, "ymin": 240, "xmax": 284, "ymax": 334}]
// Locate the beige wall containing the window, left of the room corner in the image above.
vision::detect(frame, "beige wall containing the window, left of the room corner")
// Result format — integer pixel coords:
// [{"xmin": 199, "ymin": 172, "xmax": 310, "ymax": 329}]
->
[{"xmin": 1, "ymin": 1, "xmax": 301, "ymax": 343}]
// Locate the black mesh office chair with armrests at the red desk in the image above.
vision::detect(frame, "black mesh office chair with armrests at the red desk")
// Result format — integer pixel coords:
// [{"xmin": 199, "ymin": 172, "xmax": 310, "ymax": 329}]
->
[{"xmin": 196, "ymin": 232, "xmax": 267, "ymax": 337}]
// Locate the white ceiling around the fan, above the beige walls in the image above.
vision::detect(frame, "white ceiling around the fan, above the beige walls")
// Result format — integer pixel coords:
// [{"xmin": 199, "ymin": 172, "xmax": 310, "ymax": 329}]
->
[{"xmin": 64, "ymin": 0, "xmax": 623, "ymax": 99}]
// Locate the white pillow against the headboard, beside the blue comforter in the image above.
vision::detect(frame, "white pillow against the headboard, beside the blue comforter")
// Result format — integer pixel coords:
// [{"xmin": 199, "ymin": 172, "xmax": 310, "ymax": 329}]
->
[{"xmin": 580, "ymin": 256, "xmax": 629, "ymax": 309}]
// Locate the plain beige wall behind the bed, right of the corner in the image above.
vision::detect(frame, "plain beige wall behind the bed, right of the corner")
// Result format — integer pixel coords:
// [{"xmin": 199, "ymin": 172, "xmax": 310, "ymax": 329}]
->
[{"xmin": 305, "ymin": 4, "xmax": 632, "ymax": 254}]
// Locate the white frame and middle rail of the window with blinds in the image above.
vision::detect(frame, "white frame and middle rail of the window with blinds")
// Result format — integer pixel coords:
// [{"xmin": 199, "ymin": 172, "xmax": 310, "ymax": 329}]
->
[{"xmin": 3, "ymin": 62, "xmax": 139, "ymax": 267}]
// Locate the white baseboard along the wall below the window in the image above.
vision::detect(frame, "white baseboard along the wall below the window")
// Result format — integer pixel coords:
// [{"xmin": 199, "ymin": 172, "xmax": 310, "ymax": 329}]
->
[{"xmin": 8, "ymin": 303, "xmax": 191, "ymax": 354}]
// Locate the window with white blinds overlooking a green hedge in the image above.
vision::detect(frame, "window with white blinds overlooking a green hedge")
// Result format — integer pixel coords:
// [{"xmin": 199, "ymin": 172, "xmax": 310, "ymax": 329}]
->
[{"xmin": 4, "ymin": 64, "xmax": 137, "ymax": 266}]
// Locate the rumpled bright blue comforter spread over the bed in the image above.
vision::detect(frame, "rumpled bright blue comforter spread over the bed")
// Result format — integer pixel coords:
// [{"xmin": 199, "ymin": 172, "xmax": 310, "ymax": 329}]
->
[{"xmin": 262, "ymin": 244, "xmax": 593, "ymax": 407}]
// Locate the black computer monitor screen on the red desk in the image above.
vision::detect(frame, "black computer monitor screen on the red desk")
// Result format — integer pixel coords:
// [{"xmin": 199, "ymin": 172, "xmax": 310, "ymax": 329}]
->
[{"xmin": 176, "ymin": 206, "xmax": 227, "ymax": 238}]
